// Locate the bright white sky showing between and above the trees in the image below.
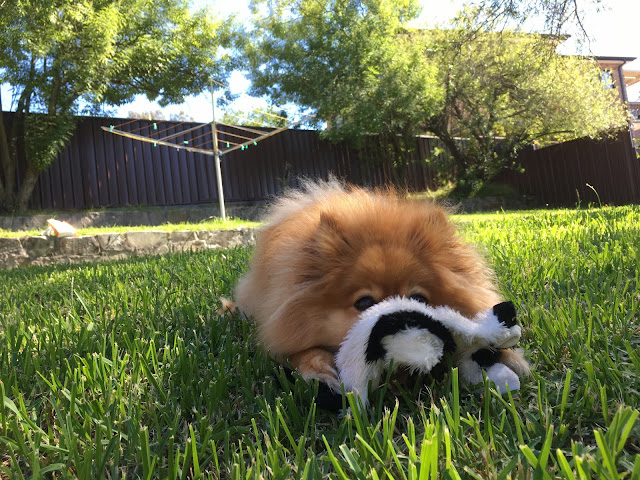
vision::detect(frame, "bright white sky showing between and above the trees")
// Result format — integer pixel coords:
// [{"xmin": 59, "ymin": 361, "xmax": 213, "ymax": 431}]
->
[{"xmin": 2, "ymin": 0, "xmax": 640, "ymax": 122}]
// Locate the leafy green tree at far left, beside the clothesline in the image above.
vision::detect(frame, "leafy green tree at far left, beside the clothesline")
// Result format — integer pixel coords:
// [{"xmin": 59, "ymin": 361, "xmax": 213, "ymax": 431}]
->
[{"xmin": 0, "ymin": 0, "xmax": 234, "ymax": 210}]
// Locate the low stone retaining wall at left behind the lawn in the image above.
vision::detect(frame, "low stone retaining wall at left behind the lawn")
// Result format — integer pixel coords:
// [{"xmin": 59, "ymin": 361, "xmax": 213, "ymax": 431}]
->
[{"xmin": 0, "ymin": 228, "xmax": 255, "ymax": 268}]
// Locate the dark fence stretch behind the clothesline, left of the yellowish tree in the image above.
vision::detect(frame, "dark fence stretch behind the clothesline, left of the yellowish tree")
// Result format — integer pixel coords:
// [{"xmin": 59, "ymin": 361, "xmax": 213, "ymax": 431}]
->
[{"xmin": 11, "ymin": 117, "xmax": 450, "ymax": 210}]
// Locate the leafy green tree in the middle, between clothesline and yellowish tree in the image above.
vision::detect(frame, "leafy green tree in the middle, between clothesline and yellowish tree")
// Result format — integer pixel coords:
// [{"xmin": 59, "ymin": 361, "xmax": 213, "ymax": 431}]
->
[{"xmin": 247, "ymin": 0, "xmax": 442, "ymax": 183}]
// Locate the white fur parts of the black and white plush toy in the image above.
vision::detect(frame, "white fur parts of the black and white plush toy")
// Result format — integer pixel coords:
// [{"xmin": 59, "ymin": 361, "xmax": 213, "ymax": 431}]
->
[{"xmin": 335, "ymin": 297, "xmax": 521, "ymax": 407}]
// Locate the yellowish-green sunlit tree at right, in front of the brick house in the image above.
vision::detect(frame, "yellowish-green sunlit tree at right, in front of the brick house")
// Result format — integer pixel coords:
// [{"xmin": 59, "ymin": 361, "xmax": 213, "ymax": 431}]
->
[{"xmin": 423, "ymin": 10, "xmax": 627, "ymax": 191}]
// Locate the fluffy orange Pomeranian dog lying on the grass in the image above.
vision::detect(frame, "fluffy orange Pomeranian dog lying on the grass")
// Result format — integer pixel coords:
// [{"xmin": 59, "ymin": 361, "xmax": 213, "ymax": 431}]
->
[{"xmin": 235, "ymin": 180, "xmax": 527, "ymax": 391}]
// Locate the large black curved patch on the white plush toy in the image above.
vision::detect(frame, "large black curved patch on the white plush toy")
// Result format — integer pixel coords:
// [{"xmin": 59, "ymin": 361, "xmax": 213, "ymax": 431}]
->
[{"xmin": 366, "ymin": 311, "xmax": 456, "ymax": 363}]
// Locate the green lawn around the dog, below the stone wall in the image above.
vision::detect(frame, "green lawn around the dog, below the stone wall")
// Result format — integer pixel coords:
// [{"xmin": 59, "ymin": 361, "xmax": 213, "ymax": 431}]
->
[{"xmin": 0, "ymin": 206, "xmax": 640, "ymax": 479}]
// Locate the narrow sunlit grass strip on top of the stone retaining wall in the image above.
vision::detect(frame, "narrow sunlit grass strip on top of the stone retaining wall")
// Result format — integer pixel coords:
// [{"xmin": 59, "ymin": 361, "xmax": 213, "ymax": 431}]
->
[{"xmin": 0, "ymin": 218, "xmax": 260, "ymax": 238}]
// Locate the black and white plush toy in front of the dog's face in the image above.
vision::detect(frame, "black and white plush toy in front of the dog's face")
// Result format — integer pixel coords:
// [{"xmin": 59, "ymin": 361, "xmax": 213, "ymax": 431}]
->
[{"xmin": 321, "ymin": 297, "xmax": 521, "ymax": 408}]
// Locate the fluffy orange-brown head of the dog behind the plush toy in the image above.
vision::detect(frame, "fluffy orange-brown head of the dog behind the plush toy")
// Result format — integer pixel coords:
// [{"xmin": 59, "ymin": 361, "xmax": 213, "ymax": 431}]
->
[{"xmin": 300, "ymin": 189, "xmax": 498, "ymax": 348}]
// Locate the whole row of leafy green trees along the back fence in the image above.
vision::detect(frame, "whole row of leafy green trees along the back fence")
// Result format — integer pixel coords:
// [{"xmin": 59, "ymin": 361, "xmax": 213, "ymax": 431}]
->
[{"xmin": 0, "ymin": 0, "xmax": 626, "ymax": 211}]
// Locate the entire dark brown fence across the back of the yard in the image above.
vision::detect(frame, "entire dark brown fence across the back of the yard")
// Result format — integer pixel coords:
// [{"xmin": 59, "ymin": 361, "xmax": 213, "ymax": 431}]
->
[{"xmin": 6, "ymin": 117, "xmax": 640, "ymax": 210}]
